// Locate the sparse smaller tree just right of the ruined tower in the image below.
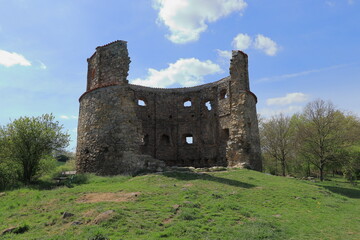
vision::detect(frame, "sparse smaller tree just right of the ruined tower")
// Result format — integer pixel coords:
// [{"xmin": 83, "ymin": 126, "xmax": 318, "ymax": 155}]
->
[{"xmin": 260, "ymin": 114, "xmax": 294, "ymax": 176}]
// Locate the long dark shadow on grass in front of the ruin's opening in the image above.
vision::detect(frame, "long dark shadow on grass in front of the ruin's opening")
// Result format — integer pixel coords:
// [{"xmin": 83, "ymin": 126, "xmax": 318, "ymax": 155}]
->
[{"xmin": 163, "ymin": 172, "xmax": 256, "ymax": 188}]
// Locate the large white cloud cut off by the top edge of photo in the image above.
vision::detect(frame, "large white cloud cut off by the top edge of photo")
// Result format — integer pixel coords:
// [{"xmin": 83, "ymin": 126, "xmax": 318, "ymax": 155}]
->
[{"xmin": 153, "ymin": 0, "xmax": 247, "ymax": 43}]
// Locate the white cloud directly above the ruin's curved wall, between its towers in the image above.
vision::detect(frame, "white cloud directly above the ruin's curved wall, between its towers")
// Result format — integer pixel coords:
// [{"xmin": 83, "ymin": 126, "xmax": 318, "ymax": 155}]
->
[{"xmin": 131, "ymin": 58, "xmax": 221, "ymax": 88}]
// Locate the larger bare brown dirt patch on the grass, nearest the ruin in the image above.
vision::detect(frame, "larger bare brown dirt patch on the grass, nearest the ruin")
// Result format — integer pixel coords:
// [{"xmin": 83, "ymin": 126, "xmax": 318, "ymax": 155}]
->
[{"xmin": 76, "ymin": 192, "xmax": 140, "ymax": 203}]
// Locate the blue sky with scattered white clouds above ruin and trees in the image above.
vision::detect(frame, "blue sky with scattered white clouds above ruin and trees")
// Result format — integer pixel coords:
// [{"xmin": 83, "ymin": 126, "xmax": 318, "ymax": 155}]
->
[{"xmin": 0, "ymin": 0, "xmax": 360, "ymax": 150}]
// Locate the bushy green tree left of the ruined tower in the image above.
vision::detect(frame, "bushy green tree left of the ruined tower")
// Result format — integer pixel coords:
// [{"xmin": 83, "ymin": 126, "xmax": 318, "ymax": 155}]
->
[{"xmin": 0, "ymin": 114, "xmax": 69, "ymax": 183}]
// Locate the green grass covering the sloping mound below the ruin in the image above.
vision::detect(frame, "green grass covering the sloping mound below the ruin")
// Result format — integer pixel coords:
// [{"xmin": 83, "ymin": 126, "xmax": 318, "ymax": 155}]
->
[{"xmin": 0, "ymin": 170, "xmax": 360, "ymax": 240}]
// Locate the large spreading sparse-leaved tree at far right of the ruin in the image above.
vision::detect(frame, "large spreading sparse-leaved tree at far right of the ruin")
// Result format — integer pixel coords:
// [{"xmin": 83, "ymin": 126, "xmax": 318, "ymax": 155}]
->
[{"xmin": 298, "ymin": 99, "xmax": 355, "ymax": 181}]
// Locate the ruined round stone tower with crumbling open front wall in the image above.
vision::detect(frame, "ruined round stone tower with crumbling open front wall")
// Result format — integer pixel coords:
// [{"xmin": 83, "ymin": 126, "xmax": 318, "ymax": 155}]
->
[{"xmin": 77, "ymin": 41, "xmax": 262, "ymax": 175}]
